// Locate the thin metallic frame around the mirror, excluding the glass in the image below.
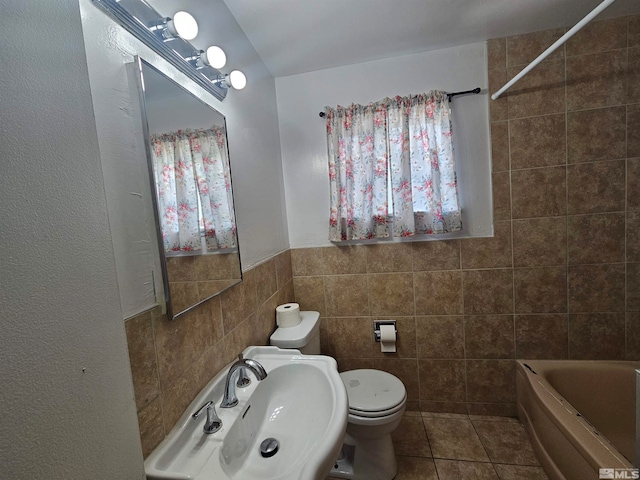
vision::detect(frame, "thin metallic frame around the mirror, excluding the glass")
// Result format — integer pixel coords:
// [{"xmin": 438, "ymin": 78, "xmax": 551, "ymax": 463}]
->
[{"xmin": 131, "ymin": 55, "xmax": 243, "ymax": 320}]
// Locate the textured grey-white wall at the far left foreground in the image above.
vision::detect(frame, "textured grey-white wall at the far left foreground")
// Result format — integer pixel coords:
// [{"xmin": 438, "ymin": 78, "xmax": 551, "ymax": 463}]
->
[{"xmin": 0, "ymin": 0, "xmax": 144, "ymax": 480}]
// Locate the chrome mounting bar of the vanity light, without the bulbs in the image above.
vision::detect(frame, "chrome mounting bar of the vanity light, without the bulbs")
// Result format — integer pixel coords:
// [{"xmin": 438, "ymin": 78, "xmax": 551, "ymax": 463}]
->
[{"xmin": 92, "ymin": 0, "xmax": 227, "ymax": 100}]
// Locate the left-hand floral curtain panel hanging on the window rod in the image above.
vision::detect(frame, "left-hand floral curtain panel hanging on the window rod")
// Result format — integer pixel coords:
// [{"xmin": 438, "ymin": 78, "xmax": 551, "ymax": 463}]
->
[{"xmin": 326, "ymin": 104, "xmax": 389, "ymax": 241}]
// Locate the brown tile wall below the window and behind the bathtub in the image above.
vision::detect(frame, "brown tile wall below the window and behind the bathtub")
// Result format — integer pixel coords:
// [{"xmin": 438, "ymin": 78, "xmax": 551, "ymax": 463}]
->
[{"xmin": 291, "ymin": 17, "xmax": 640, "ymax": 414}]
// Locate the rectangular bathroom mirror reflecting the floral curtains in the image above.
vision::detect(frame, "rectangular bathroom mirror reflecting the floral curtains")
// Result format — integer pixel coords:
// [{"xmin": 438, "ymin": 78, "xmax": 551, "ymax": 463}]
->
[{"xmin": 134, "ymin": 58, "xmax": 242, "ymax": 318}]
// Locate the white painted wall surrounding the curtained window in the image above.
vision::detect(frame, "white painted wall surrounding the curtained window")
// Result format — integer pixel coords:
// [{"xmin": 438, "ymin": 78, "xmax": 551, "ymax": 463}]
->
[{"xmin": 276, "ymin": 43, "xmax": 493, "ymax": 248}]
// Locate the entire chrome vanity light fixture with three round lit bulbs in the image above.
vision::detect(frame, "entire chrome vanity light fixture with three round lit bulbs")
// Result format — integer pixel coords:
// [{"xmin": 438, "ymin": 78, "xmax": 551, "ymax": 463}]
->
[{"xmin": 92, "ymin": 0, "xmax": 247, "ymax": 100}]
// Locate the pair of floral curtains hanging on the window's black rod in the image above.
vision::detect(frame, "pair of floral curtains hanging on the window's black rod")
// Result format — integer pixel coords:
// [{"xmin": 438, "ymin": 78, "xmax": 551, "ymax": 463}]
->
[{"xmin": 325, "ymin": 91, "xmax": 462, "ymax": 241}]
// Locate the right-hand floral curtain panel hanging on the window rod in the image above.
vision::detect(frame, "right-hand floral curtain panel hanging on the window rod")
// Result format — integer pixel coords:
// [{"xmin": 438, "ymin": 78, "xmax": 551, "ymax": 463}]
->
[{"xmin": 387, "ymin": 91, "xmax": 462, "ymax": 237}]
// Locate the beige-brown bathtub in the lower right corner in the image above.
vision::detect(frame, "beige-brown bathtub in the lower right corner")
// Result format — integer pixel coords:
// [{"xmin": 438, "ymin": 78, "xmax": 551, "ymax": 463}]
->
[{"xmin": 516, "ymin": 360, "xmax": 640, "ymax": 480}]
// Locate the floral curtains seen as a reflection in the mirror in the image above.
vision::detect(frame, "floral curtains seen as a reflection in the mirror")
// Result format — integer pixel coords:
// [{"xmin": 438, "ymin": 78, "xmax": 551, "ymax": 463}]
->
[{"xmin": 150, "ymin": 127, "xmax": 236, "ymax": 252}]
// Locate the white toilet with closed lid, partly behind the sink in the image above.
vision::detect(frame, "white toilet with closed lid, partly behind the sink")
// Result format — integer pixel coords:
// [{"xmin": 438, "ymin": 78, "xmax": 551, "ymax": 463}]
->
[{"xmin": 270, "ymin": 312, "xmax": 407, "ymax": 480}]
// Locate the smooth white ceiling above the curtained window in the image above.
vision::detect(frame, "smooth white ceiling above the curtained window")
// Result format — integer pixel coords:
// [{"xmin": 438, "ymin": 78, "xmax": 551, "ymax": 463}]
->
[{"xmin": 224, "ymin": 0, "xmax": 640, "ymax": 77}]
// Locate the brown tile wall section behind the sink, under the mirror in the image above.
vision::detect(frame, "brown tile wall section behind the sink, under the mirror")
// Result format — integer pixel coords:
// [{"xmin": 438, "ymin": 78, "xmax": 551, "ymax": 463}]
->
[{"xmin": 125, "ymin": 251, "xmax": 294, "ymax": 457}]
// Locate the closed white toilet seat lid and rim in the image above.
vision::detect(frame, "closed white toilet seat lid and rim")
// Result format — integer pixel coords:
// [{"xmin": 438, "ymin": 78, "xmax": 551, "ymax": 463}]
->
[{"xmin": 340, "ymin": 369, "xmax": 407, "ymax": 418}]
